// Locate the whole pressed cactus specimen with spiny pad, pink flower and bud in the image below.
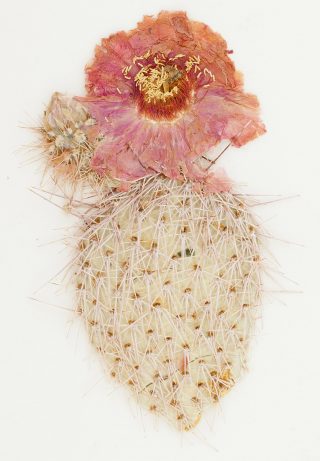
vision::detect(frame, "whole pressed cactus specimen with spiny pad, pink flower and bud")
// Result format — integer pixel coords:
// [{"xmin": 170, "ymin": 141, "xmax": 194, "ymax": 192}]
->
[{"xmin": 35, "ymin": 12, "xmax": 265, "ymax": 430}]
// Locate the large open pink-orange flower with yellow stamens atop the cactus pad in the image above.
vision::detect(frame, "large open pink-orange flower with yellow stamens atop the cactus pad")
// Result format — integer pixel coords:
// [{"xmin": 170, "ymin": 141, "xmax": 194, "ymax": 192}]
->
[{"xmin": 77, "ymin": 12, "xmax": 265, "ymax": 192}]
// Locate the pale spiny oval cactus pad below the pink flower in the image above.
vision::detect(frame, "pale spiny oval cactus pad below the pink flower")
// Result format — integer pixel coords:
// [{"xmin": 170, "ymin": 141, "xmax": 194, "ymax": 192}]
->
[{"xmin": 77, "ymin": 176, "xmax": 261, "ymax": 430}]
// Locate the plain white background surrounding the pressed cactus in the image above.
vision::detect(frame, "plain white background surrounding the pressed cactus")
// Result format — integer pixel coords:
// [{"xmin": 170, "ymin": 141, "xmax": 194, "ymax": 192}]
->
[{"xmin": 0, "ymin": 0, "xmax": 320, "ymax": 461}]
